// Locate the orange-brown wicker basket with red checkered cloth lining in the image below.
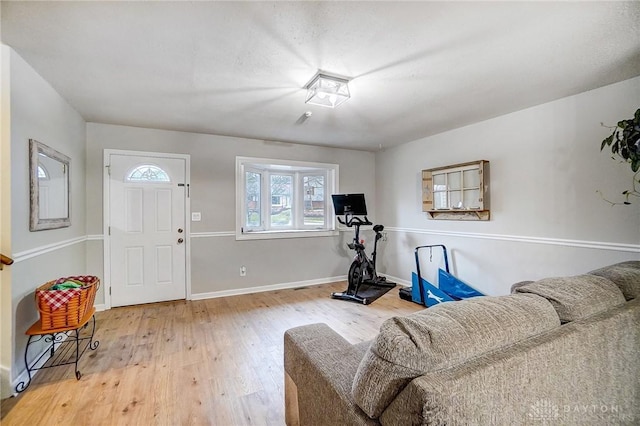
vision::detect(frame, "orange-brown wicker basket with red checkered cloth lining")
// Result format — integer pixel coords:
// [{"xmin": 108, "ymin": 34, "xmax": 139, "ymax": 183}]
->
[{"xmin": 35, "ymin": 275, "xmax": 100, "ymax": 330}]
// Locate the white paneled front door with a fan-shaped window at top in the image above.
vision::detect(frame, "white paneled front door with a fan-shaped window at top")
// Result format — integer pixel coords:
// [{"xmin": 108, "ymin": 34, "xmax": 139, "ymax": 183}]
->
[{"xmin": 107, "ymin": 153, "xmax": 187, "ymax": 306}]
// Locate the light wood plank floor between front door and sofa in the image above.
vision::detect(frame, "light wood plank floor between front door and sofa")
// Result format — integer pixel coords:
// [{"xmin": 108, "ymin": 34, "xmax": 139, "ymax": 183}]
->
[{"xmin": 0, "ymin": 283, "xmax": 420, "ymax": 426}]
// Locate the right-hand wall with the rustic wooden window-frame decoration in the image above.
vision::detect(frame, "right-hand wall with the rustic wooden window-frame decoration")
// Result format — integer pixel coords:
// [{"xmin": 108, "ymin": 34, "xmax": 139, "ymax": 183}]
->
[{"xmin": 376, "ymin": 78, "xmax": 640, "ymax": 295}]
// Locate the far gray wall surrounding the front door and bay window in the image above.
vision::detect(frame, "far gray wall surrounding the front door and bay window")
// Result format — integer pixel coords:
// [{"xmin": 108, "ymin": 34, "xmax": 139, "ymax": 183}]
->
[{"xmin": 87, "ymin": 123, "xmax": 375, "ymax": 298}]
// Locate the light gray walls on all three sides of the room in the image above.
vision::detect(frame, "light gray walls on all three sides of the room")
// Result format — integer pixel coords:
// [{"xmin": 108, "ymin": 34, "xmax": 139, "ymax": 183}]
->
[{"xmin": 1, "ymin": 44, "xmax": 640, "ymax": 400}]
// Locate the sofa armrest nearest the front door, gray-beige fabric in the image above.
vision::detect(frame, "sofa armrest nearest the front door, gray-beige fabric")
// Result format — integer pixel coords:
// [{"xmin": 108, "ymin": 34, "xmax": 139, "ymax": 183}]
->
[{"xmin": 284, "ymin": 324, "xmax": 379, "ymax": 426}]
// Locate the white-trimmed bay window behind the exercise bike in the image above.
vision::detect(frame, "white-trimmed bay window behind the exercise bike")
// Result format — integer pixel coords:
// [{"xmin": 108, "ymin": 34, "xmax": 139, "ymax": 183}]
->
[{"xmin": 236, "ymin": 157, "xmax": 338, "ymax": 239}]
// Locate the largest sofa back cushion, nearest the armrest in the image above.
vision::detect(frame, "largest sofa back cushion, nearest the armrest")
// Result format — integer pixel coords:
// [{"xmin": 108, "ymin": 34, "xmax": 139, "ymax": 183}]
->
[{"xmin": 352, "ymin": 294, "xmax": 560, "ymax": 418}]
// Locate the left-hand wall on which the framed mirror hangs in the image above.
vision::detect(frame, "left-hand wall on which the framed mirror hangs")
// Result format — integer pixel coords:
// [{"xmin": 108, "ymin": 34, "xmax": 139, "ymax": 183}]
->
[{"xmin": 2, "ymin": 50, "xmax": 86, "ymax": 396}]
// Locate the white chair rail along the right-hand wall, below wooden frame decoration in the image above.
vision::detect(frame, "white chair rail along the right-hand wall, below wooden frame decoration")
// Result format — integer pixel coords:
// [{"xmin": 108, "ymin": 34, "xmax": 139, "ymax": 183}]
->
[{"xmin": 385, "ymin": 227, "xmax": 640, "ymax": 253}]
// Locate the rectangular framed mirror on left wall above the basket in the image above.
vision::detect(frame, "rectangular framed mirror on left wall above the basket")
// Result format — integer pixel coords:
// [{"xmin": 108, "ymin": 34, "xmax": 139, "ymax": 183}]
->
[{"xmin": 29, "ymin": 139, "xmax": 71, "ymax": 231}]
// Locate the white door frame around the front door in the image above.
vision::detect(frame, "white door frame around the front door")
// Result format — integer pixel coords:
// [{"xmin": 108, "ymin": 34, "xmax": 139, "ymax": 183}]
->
[{"xmin": 102, "ymin": 149, "xmax": 191, "ymax": 309}]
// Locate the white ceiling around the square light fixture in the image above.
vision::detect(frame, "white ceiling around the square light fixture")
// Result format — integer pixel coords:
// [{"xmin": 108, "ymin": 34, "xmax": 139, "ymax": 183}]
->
[{"xmin": 1, "ymin": 1, "xmax": 640, "ymax": 150}]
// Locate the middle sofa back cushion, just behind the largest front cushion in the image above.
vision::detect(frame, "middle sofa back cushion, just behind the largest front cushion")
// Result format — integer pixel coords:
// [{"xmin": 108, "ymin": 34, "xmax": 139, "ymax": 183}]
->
[{"xmin": 515, "ymin": 274, "xmax": 625, "ymax": 322}]
